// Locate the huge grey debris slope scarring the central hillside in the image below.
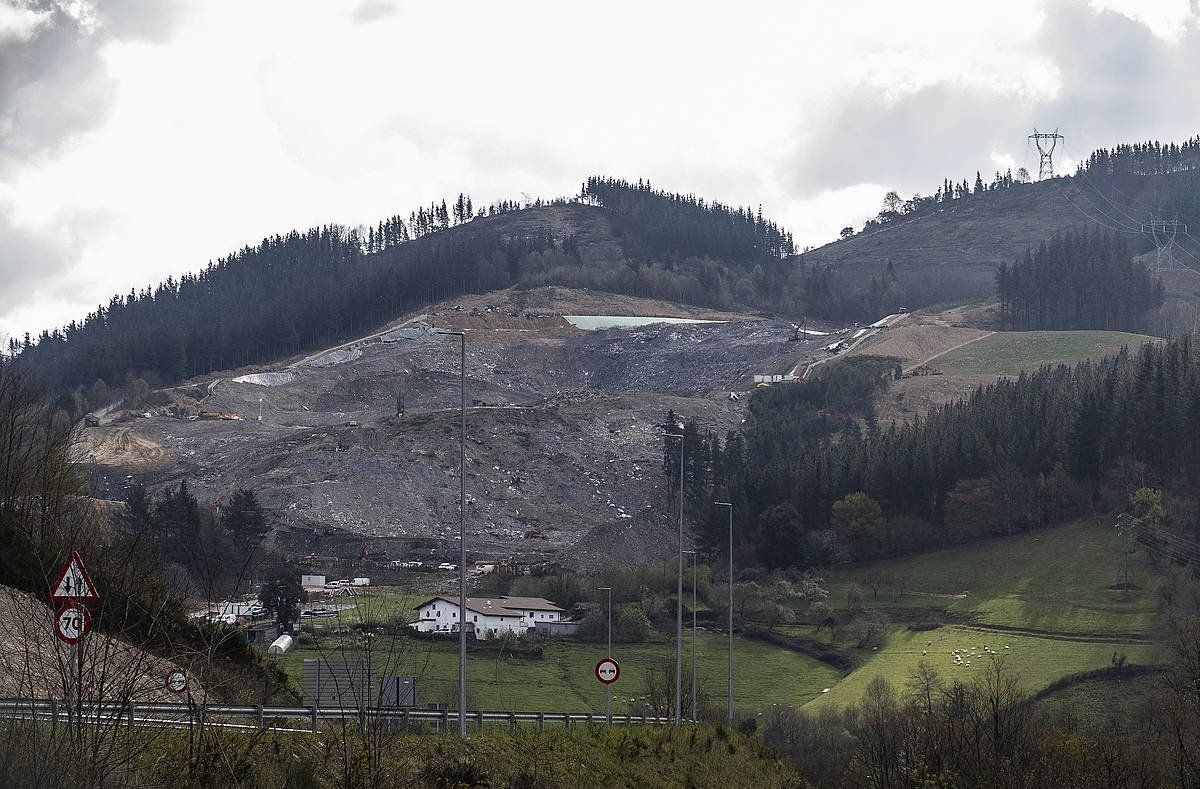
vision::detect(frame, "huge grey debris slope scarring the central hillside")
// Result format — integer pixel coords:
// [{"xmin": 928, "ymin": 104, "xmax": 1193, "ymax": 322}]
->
[{"xmin": 85, "ymin": 288, "xmax": 840, "ymax": 564}]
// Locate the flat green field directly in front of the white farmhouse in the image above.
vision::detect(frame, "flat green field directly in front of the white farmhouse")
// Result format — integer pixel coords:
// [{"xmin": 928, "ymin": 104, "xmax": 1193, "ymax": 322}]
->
[{"xmin": 267, "ymin": 632, "xmax": 841, "ymax": 712}]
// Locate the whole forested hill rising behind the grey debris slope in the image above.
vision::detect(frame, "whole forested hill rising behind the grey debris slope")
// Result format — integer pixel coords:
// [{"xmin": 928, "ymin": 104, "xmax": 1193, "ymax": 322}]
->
[{"xmin": 8, "ymin": 177, "xmax": 811, "ymax": 400}]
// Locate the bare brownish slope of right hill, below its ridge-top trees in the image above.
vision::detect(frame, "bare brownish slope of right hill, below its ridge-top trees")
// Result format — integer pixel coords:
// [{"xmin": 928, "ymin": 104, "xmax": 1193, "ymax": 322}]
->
[{"xmin": 798, "ymin": 165, "xmax": 1200, "ymax": 333}]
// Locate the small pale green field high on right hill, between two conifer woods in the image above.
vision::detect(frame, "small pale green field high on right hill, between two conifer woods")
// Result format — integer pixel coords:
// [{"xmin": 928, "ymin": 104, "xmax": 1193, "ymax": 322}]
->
[{"xmin": 930, "ymin": 331, "xmax": 1154, "ymax": 375}]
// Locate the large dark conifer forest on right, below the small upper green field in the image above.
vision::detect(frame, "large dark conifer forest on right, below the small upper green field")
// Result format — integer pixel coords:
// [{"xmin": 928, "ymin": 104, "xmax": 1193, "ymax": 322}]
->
[{"xmin": 664, "ymin": 336, "xmax": 1200, "ymax": 567}]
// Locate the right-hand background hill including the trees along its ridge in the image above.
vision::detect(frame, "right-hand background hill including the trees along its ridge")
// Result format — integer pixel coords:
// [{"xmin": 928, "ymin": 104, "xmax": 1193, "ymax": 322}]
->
[{"xmin": 800, "ymin": 131, "xmax": 1200, "ymax": 332}]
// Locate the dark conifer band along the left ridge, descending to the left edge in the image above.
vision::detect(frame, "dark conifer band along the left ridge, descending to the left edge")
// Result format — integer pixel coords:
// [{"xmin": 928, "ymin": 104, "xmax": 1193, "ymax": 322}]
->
[{"xmin": 10, "ymin": 214, "xmax": 554, "ymax": 406}]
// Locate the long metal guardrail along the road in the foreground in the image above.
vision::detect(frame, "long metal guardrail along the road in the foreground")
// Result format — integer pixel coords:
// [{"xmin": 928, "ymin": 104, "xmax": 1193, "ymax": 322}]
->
[{"xmin": 0, "ymin": 699, "xmax": 672, "ymax": 733}]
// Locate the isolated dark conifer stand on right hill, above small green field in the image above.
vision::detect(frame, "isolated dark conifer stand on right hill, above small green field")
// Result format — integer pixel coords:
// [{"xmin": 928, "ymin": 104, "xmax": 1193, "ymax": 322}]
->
[{"xmin": 996, "ymin": 229, "xmax": 1163, "ymax": 331}]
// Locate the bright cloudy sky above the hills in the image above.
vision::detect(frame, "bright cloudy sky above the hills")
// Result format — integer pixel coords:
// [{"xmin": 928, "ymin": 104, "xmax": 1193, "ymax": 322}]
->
[{"xmin": 0, "ymin": 0, "xmax": 1200, "ymax": 337}]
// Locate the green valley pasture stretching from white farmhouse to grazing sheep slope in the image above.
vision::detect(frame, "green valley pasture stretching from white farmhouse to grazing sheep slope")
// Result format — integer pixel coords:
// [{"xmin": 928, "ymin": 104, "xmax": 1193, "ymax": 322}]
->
[{"xmin": 281, "ymin": 520, "xmax": 1162, "ymax": 711}]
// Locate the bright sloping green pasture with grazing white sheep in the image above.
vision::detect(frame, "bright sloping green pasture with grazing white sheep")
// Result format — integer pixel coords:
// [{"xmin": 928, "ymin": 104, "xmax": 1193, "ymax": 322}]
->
[{"xmin": 797, "ymin": 522, "xmax": 1162, "ymax": 706}]
